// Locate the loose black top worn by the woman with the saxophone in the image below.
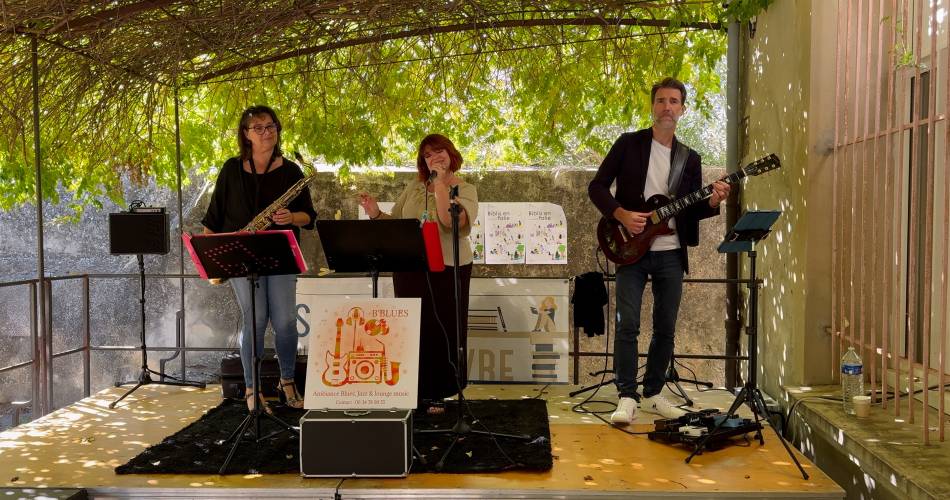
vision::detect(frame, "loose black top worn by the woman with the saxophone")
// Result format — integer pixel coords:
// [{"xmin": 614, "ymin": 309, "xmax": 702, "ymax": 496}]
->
[{"xmin": 201, "ymin": 157, "xmax": 317, "ymax": 242}]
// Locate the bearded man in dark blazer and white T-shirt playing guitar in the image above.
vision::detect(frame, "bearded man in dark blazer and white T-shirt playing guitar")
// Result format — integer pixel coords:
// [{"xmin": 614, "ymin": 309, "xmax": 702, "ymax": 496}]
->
[{"xmin": 588, "ymin": 78, "xmax": 729, "ymax": 424}]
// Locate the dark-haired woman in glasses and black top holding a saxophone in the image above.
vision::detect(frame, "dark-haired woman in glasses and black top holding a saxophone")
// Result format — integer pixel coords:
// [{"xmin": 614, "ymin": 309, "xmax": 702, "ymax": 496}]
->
[{"xmin": 201, "ymin": 106, "xmax": 316, "ymax": 413}]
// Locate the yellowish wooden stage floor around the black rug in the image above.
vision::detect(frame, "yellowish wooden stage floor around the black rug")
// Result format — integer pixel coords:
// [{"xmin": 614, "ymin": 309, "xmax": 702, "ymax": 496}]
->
[{"xmin": 0, "ymin": 385, "xmax": 844, "ymax": 499}]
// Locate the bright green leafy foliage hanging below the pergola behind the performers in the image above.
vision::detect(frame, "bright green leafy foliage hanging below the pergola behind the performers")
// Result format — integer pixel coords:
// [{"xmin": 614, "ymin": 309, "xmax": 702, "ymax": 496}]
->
[{"xmin": 0, "ymin": 0, "xmax": 772, "ymax": 211}]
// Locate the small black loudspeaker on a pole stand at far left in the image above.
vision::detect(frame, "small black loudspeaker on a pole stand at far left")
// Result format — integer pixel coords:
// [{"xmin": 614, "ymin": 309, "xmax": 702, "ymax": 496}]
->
[{"xmin": 109, "ymin": 207, "xmax": 168, "ymax": 255}]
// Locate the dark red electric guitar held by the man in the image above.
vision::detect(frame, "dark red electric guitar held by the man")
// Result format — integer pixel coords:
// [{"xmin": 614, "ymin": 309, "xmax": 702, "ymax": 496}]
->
[{"xmin": 597, "ymin": 154, "xmax": 782, "ymax": 265}]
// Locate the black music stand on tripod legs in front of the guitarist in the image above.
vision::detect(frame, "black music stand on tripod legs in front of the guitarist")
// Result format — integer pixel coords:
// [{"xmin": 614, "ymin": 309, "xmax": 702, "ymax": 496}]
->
[{"xmin": 686, "ymin": 210, "xmax": 808, "ymax": 479}]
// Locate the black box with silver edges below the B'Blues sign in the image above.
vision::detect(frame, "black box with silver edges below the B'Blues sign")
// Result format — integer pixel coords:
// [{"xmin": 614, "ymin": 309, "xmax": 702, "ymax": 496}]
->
[{"xmin": 300, "ymin": 410, "xmax": 412, "ymax": 477}]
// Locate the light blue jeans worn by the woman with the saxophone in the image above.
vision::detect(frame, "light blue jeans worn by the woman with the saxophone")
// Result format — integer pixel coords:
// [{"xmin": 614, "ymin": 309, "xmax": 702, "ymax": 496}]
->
[{"xmin": 229, "ymin": 274, "xmax": 297, "ymax": 389}]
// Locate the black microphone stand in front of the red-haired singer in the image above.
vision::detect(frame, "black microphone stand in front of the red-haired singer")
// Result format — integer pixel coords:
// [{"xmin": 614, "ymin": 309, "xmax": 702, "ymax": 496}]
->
[{"xmin": 416, "ymin": 182, "xmax": 531, "ymax": 471}]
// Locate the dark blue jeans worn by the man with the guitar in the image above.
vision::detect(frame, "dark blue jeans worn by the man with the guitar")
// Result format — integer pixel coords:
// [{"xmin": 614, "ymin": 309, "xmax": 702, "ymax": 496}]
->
[{"xmin": 614, "ymin": 250, "xmax": 683, "ymax": 398}]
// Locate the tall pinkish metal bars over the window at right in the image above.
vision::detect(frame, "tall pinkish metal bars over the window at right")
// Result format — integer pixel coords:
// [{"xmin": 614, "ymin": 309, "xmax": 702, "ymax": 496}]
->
[{"xmin": 831, "ymin": 0, "xmax": 950, "ymax": 444}]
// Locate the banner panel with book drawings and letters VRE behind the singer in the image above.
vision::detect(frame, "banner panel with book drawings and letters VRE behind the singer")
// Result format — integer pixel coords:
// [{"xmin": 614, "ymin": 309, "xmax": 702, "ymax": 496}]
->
[{"xmin": 467, "ymin": 278, "xmax": 570, "ymax": 384}]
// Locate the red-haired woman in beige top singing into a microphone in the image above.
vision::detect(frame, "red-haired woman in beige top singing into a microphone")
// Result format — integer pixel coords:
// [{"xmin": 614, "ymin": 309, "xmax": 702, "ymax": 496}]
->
[{"xmin": 359, "ymin": 134, "xmax": 478, "ymax": 413}]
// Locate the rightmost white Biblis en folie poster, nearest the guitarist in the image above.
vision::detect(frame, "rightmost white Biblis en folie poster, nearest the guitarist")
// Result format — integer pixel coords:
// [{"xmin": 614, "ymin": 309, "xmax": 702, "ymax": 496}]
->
[{"xmin": 525, "ymin": 203, "xmax": 567, "ymax": 264}]
